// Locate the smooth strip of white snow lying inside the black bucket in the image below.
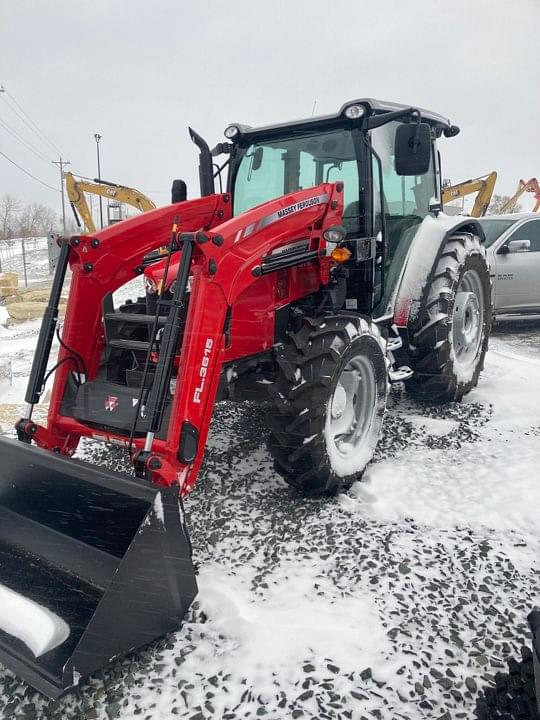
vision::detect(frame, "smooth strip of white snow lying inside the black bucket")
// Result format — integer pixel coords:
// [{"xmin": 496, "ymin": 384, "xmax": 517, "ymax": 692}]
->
[{"xmin": 0, "ymin": 585, "xmax": 69, "ymax": 657}]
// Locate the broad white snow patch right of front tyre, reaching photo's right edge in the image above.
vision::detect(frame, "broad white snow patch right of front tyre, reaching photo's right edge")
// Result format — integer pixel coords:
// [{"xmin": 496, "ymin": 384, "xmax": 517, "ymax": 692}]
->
[{"xmin": 348, "ymin": 338, "xmax": 540, "ymax": 536}]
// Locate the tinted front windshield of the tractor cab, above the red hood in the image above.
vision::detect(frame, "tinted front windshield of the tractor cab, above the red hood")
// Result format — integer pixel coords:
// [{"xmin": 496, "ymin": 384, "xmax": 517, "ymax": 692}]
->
[{"xmin": 234, "ymin": 129, "xmax": 359, "ymax": 231}]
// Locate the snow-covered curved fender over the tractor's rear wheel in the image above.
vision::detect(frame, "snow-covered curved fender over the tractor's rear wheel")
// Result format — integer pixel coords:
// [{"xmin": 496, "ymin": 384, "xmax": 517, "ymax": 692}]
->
[{"xmin": 386, "ymin": 213, "xmax": 484, "ymax": 328}]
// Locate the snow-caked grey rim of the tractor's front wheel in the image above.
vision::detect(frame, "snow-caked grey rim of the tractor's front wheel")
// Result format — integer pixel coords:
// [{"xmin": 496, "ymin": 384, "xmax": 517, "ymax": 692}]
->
[{"xmin": 326, "ymin": 356, "xmax": 377, "ymax": 458}]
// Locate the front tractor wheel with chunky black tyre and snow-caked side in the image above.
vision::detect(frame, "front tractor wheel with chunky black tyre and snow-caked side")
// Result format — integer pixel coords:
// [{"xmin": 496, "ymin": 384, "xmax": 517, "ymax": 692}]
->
[{"xmin": 268, "ymin": 313, "xmax": 388, "ymax": 495}]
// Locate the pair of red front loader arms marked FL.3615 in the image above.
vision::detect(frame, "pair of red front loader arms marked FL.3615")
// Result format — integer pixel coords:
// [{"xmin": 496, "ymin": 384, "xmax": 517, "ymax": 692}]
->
[{"xmin": 22, "ymin": 183, "xmax": 343, "ymax": 494}]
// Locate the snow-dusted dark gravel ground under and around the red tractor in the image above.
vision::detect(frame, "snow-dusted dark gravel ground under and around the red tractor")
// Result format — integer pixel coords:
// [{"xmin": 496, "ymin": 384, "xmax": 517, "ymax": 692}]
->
[{"xmin": 0, "ymin": 324, "xmax": 540, "ymax": 720}]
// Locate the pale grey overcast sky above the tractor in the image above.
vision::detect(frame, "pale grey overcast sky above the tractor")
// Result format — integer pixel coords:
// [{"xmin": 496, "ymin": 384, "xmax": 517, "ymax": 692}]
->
[{"xmin": 0, "ymin": 0, "xmax": 540, "ymax": 222}]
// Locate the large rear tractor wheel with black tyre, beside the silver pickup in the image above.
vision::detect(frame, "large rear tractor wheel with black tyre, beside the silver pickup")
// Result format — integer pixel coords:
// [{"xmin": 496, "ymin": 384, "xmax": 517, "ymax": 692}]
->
[{"xmin": 406, "ymin": 233, "xmax": 491, "ymax": 402}]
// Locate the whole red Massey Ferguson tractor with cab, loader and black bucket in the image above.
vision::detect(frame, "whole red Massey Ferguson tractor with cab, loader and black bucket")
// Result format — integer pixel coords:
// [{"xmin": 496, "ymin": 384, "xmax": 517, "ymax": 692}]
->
[{"xmin": 0, "ymin": 99, "xmax": 491, "ymax": 697}]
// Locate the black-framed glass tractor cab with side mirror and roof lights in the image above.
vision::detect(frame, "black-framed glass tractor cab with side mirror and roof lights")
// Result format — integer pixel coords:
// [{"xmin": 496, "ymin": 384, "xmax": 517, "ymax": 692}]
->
[{"xmin": 192, "ymin": 99, "xmax": 459, "ymax": 315}]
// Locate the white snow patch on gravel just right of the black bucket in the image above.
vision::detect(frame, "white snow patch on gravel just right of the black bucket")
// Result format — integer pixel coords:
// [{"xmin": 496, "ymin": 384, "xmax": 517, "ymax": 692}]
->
[{"xmin": 196, "ymin": 561, "xmax": 391, "ymax": 691}]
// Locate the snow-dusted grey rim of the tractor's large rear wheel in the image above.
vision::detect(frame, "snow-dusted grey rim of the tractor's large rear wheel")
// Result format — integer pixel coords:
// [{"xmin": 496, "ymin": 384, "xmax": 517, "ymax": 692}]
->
[{"xmin": 452, "ymin": 270, "xmax": 484, "ymax": 369}]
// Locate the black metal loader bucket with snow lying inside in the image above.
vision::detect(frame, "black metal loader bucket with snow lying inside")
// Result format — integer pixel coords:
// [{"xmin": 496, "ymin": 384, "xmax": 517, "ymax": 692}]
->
[{"xmin": 0, "ymin": 438, "xmax": 197, "ymax": 699}]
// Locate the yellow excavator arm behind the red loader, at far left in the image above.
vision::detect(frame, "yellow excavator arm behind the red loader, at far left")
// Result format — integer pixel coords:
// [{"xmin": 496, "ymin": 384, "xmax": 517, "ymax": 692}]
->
[{"xmin": 64, "ymin": 172, "xmax": 156, "ymax": 233}]
